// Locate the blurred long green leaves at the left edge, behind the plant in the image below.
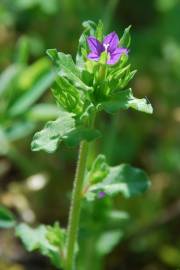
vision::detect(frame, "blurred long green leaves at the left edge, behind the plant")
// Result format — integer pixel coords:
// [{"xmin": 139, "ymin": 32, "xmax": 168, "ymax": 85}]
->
[{"xmin": 0, "ymin": 37, "xmax": 58, "ymax": 160}]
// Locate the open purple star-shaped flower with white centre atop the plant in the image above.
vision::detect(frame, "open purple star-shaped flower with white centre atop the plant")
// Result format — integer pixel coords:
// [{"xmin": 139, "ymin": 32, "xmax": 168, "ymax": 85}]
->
[{"xmin": 87, "ymin": 32, "xmax": 128, "ymax": 65}]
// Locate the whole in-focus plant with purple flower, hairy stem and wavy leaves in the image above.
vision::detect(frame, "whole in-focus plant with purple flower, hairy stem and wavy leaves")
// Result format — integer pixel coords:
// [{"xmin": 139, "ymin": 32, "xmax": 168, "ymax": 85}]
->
[{"xmin": 0, "ymin": 21, "xmax": 153, "ymax": 270}]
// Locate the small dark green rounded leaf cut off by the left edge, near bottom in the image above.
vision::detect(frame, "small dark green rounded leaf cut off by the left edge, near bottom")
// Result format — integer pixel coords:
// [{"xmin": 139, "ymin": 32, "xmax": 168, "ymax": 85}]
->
[{"xmin": 0, "ymin": 206, "xmax": 16, "ymax": 229}]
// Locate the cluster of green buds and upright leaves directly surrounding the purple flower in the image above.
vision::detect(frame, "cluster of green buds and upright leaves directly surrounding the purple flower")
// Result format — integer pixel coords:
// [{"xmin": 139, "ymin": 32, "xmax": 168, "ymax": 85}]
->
[{"xmin": 47, "ymin": 21, "xmax": 152, "ymax": 124}]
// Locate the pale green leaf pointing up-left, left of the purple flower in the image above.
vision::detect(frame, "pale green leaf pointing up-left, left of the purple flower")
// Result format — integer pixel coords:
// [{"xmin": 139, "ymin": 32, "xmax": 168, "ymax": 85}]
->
[{"xmin": 47, "ymin": 49, "xmax": 92, "ymax": 91}]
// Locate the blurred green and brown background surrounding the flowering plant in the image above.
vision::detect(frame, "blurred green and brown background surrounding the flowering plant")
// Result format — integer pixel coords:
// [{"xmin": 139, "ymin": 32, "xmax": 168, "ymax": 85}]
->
[{"xmin": 0, "ymin": 0, "xmax": 180, "ymax": 270}]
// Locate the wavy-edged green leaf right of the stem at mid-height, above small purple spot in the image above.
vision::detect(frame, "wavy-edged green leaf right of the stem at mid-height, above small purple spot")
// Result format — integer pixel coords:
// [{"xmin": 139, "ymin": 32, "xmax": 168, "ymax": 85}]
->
[{"xmin": 85, "ymin": 160, "xmax": 150, "ymax": 200}]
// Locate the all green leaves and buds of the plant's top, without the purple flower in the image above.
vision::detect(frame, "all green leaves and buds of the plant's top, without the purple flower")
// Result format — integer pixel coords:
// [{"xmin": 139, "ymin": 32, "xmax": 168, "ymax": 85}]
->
[{"xmin": 32, "ymin": 21, "xmax": 152, "ymax": 156}]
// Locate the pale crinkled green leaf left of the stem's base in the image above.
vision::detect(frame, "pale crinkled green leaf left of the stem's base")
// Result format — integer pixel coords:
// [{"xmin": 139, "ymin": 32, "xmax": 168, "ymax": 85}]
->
[{"xmin": 16, "ymin": 223, "xmax": 65, "ymax": 269}]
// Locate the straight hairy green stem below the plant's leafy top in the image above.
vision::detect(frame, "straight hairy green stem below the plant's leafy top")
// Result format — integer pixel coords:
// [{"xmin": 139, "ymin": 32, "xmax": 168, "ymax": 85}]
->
[{"xmin": 65, "ymin": 115, "xmax": 94, "ymax": 270}]
